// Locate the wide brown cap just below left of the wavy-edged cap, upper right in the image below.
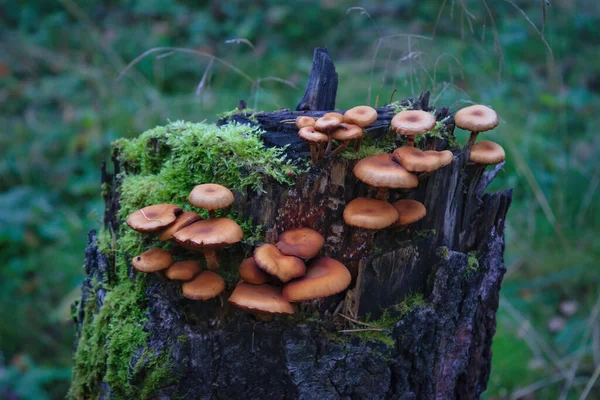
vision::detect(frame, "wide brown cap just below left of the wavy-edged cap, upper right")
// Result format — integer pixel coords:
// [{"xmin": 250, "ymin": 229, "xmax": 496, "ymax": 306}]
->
[{"xmin": 353, "ymin": 154, "xmax": 419, "ymax": 189}]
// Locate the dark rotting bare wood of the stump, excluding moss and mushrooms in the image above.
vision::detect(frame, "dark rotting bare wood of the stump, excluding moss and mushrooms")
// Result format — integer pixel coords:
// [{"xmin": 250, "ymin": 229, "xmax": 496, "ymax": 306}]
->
[{"xmin": 70, "ymin": 50, "xmax": 511, "ymax": 399}]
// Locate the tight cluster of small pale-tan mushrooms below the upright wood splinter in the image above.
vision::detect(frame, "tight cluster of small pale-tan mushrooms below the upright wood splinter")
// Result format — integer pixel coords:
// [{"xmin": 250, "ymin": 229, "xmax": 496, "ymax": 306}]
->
[{"xmin": 295, "ymin": 106, "xmax": 377, "ymax": 165}]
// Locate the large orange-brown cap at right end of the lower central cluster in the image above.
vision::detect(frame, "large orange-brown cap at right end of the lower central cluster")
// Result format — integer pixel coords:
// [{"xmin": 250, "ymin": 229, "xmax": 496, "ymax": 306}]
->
[{"xmin": 282, "ymin": 257, "xmax": 352, "ymax": 302}]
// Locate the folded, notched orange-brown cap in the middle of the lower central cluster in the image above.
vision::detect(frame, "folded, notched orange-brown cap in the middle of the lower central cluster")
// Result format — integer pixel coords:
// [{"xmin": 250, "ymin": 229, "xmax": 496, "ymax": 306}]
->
[{"xmin": 254, "ymin": 244, "xmax": 306, "ymax": 282}]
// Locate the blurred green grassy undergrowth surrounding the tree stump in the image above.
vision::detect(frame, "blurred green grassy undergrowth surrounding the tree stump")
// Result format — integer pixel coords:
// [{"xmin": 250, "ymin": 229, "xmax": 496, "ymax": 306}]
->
[{"xmin": 0, "ymin": 0, "xmax": 600, "ymax": 399}]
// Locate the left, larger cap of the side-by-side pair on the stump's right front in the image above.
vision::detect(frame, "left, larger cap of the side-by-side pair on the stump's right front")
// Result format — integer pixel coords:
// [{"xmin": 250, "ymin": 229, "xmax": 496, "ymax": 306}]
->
[{"xmin": 344, "ymin": 197, "xmax": 398, "ymax": 229}]
